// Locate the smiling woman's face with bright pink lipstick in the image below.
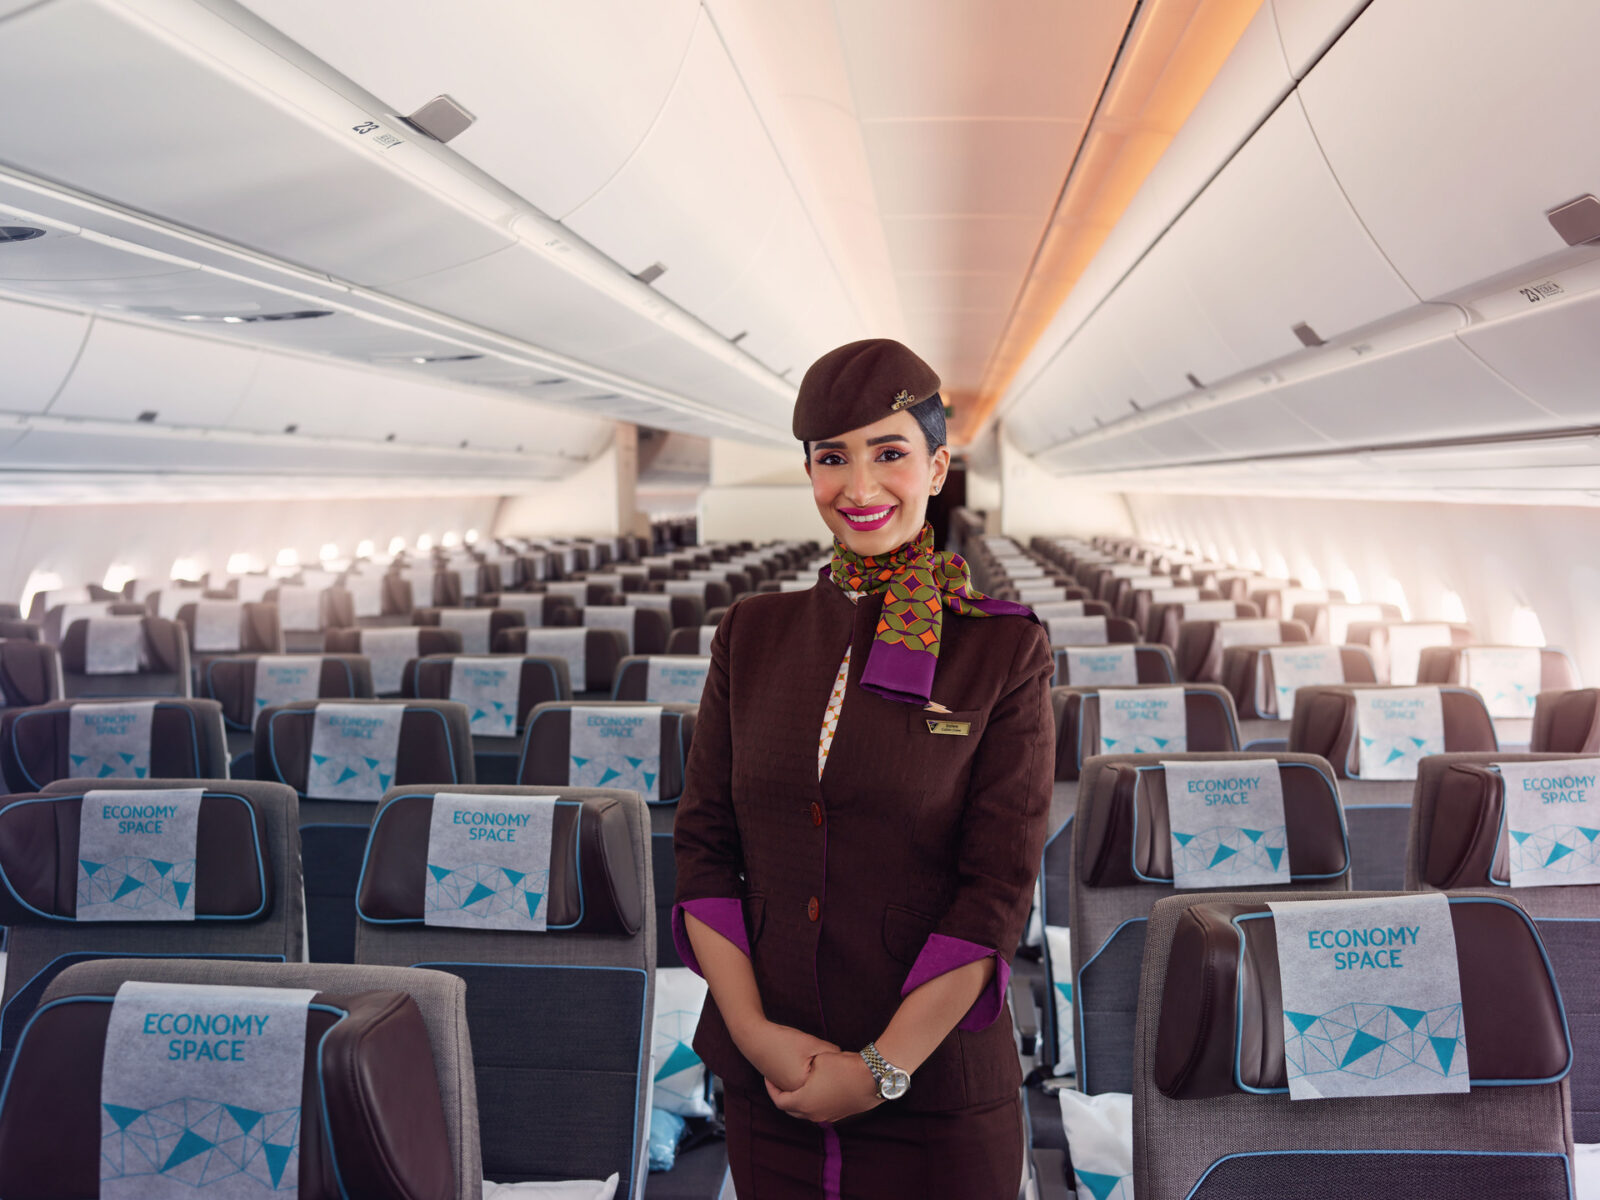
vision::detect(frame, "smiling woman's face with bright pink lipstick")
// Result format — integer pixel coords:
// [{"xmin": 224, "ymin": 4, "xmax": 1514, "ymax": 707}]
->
[{"xmin": 805, "ymin": 410, "xmax": 950, "ymax": 555}]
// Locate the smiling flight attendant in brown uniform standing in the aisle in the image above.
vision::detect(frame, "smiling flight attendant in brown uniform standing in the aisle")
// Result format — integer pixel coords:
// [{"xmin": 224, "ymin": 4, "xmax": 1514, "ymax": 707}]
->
[{"xmin": 672, "ymin": 339, "xmax": 1054, "ymax": 1200}]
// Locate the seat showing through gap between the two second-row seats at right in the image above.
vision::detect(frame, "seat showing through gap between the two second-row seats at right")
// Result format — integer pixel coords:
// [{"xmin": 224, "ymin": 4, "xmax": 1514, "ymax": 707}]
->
[{"xmin": 1290, "ymin": 685, "xmax": 1498, "ymax": 890}]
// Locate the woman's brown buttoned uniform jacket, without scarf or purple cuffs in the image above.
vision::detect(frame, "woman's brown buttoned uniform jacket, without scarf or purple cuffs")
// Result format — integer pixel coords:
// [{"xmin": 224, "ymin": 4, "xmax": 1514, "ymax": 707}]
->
[{"xmin": 674, "ymin": 581, "xmax": 1054, "ymax": 1112}]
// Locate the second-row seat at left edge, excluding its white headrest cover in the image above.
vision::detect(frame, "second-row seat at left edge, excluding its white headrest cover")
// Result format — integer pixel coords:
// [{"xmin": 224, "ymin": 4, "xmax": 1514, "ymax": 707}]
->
[{"xmin": 0, "ymin": 779, "xmax": 306, "ymax": 1048}]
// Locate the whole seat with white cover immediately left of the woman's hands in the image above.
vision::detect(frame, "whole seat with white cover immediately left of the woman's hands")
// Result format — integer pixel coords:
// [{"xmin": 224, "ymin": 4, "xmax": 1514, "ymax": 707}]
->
[{"xmin": 355, "ymin": 786, "xmax": 667, "ymax": 1197}]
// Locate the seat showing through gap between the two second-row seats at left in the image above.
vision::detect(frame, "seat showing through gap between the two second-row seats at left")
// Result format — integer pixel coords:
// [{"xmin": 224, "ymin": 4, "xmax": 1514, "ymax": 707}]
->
[{"xmin": 254, "ymin": 699, "xmax": 477, "ymax": 962}]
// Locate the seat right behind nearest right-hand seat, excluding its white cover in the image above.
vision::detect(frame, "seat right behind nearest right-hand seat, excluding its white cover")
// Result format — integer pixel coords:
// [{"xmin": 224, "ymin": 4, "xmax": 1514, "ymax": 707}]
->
[{"xmin": 1046, "ymin": 752, "xmax": 1350, "ymax": 1093}]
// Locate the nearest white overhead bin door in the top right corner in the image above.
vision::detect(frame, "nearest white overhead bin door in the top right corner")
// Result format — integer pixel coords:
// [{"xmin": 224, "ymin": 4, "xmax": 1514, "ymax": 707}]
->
[{"xmin": 1299, "ymin": 0, "xmax": 1600, "ymax": 299}]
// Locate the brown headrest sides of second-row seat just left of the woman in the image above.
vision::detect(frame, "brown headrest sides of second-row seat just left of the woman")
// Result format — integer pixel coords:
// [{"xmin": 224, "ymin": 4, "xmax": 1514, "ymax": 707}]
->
[{"xmin": 355, "ymin": 800, "xmax": 645, "ymax": 936}]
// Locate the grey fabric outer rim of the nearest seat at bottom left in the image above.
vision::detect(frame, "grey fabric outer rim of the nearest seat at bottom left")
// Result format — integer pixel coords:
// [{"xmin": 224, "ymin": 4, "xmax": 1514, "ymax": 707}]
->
[{"xmin": 45, "ymin": 958, "xmax": 483, "ymax": 1200}]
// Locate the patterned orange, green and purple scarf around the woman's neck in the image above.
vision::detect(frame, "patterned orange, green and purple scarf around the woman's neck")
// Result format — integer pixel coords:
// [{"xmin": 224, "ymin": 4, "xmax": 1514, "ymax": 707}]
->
[{"xmin": 829, "ymin": 525, "xmax": 1034, "ymax": 706}]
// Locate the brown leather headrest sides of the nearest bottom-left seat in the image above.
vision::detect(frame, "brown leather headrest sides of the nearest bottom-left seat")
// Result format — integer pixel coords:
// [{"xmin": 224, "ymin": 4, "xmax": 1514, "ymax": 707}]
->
[{"xmin": 0, "ymin": 992, "xmax": 457, "ymax": 1200}]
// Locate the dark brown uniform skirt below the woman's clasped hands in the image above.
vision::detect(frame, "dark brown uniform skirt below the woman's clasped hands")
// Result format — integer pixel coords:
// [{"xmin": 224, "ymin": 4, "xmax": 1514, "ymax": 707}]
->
[{"xmin": 726, "ymin": 1091, "xmax": 1022, "ymax": 1200}]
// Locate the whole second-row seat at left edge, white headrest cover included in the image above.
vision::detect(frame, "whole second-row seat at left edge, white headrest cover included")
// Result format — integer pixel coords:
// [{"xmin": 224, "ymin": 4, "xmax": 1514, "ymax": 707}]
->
[{"xmin": 0, "ymin": 778, "xmax": 304, "ymax": 1056}]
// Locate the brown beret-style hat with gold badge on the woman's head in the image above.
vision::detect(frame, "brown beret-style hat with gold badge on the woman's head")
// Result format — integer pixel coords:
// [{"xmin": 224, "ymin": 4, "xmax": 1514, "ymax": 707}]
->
[{"xmin": 794, "ymin": 338, "xmax": 939, "ymax": 442}]
